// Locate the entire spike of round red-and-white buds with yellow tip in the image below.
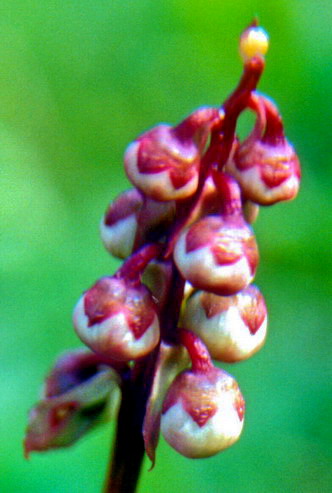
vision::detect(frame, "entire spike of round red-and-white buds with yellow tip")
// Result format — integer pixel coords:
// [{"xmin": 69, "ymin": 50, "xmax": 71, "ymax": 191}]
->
[{"xmin": 26, "ymin": 20, "xmax": 300, "ymax": 488}]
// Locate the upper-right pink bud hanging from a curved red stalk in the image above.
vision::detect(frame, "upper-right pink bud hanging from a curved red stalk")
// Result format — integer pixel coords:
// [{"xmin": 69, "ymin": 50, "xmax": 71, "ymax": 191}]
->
[{"xmin": 226, "ymin": 95, "xmax": 301, "ymax": 205}]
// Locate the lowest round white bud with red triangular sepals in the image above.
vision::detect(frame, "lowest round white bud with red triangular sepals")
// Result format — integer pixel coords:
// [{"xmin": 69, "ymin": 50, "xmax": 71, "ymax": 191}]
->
[{"xmin": 161, "ymin": 368, "xmax": 245, "ymax": 459}]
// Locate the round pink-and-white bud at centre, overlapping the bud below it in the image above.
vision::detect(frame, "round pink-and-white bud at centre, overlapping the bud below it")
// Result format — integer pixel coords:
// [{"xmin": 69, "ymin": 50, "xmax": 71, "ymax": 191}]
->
[{"xmin": 174, "ymin": 215, "xmax": 258, "ymax": 296}]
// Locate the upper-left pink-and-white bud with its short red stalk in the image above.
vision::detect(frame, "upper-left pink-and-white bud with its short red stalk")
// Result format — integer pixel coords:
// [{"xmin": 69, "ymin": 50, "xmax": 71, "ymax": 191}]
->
[{"xmin": 124, "ymin": 108, "xmax": 220, "ymax": 201}]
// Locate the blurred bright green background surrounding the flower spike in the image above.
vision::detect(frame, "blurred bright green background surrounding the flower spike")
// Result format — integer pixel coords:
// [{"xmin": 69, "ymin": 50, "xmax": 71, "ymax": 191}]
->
[{"xmin": 0, "ymin": 0, "xmax": 332, "ymax": 493}]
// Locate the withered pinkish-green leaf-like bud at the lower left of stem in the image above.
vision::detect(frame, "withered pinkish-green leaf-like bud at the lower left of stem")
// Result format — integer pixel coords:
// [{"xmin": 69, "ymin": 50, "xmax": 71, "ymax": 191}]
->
[{"xmin": 24, "ymin": 350, "xmax": 120, "ymax": 456}]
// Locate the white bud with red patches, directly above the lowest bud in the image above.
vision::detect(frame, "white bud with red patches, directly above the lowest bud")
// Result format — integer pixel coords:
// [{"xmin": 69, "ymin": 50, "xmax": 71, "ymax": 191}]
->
[{"xmin": 182, "ymin": 285, "xmax": 267, "ymax": 363}]
